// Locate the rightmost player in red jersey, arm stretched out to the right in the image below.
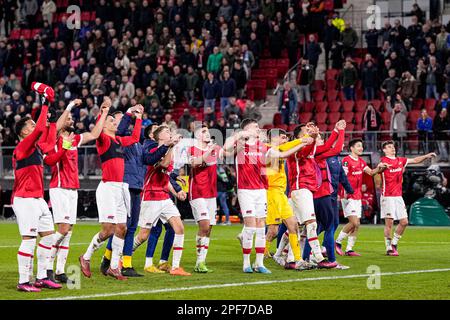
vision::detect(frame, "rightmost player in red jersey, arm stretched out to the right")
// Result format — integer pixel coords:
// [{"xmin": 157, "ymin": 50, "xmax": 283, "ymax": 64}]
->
[{"xmin": 380, "ymin": 140, "xmax": 436, "ymax": 256}]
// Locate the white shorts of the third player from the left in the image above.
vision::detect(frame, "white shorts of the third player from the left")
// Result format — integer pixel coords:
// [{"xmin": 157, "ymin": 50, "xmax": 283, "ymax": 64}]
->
[{"xmin": 95, "ymin": 181, "xmax": 130, "ymax": 224}]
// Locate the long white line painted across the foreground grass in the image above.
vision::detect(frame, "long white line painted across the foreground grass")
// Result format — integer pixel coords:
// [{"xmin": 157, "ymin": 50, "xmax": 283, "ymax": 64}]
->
[{"xmin": 38, "ymin": 268, "xmax": 450, "ymax": 300}]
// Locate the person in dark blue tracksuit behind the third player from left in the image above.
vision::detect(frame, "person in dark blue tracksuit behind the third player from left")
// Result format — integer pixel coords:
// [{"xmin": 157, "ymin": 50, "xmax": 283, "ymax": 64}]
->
[{"xmin": 100, "ymin": 108, "xmax": 146, "ymax": 277}]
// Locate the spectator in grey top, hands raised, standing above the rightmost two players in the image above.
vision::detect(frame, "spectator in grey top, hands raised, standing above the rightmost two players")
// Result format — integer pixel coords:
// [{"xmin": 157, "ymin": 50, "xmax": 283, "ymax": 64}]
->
[{"xmin": 386, "ymin": 94, "xmax": 408, "ymax": 154}]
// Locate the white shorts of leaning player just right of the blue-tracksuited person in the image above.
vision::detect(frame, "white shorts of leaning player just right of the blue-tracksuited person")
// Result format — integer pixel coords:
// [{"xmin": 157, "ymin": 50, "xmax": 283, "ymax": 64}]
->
[{"xmin": 138, "ymin": 199, "xmax": 180, "ymax": 229}]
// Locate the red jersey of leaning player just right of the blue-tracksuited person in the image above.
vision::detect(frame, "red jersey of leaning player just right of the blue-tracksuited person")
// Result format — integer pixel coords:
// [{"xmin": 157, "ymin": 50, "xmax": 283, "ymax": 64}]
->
[{"xmin": 142, "ymin": 162, "xmax": 173, "ymax": 201}]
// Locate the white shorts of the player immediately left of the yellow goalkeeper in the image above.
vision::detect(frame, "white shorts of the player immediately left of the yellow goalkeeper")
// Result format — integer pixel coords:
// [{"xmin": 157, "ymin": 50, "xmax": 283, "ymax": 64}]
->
[{"xmin": 237, "ymin": 189, "xmax": 267, "ymax": 219}]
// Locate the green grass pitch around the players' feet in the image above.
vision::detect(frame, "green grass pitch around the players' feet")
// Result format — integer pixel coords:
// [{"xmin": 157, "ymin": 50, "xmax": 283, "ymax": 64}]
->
[{"xmin": 0, "ymin": 222, "xmax": 450, "ymax": 300}]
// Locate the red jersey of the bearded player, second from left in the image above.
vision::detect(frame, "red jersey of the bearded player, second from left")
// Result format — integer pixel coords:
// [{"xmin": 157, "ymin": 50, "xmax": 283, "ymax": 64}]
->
[{"xmin": 49, "ymin": 134, "xmax": 83, "ymax": 189}]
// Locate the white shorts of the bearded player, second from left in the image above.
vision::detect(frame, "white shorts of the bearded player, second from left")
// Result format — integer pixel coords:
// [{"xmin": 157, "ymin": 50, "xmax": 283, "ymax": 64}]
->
[{"xmin": 49, "ymin": 188, "xmax": 78, "ymax": 224}]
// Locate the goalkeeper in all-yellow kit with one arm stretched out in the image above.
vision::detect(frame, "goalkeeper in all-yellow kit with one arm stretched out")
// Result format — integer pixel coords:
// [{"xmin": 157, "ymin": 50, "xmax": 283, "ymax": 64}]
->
[{"xmin": 266, "ymin": 129, "xmax": 313, "ymax": 270}]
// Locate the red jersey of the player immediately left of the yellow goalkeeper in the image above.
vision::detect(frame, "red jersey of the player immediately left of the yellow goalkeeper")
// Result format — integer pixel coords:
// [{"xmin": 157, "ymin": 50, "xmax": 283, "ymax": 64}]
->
[{"xmin": 236, "ymin": 141, "xmax": 268, "ymax": 190}]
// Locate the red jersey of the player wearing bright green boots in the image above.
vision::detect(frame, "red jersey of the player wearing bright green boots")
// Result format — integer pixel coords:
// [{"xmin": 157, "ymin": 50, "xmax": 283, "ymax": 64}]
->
[{"xmin": 189, "ymin": 146, "xmax": 220, "ymax": 200}]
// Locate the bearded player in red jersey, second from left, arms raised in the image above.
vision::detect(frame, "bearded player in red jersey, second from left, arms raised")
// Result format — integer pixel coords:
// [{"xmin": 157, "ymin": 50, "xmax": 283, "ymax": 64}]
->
[{"xmin": 44, "ymin": 97, "xmax": 111, "ymax": 283}]
